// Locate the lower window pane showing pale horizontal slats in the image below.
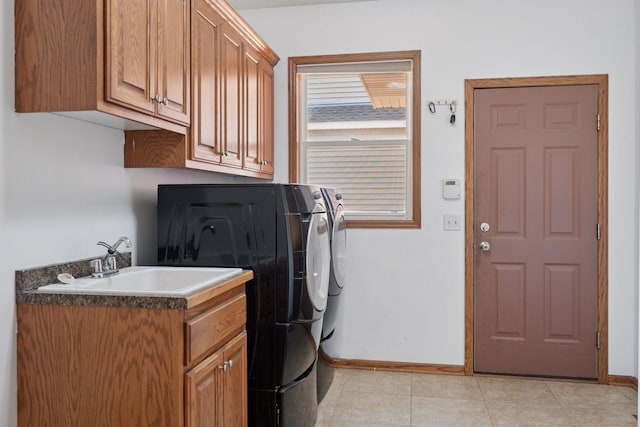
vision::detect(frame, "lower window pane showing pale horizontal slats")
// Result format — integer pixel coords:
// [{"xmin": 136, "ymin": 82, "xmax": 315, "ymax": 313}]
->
[{"xmin": 305, "ymin": 142, "xmax": 408, "ymax": 217}]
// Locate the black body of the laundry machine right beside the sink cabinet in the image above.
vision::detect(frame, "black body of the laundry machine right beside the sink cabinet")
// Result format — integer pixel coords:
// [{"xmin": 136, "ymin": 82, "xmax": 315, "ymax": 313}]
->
[{"xmin": 158, "ymin": 184, "xmax": 328, "ymax": 426}]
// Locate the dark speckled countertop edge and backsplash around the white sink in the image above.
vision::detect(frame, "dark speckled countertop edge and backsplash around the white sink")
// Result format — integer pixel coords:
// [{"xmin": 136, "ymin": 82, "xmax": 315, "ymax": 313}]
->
[{"xmin": 15, "ymin": 253, "xmax": 248, "ymax": 309}]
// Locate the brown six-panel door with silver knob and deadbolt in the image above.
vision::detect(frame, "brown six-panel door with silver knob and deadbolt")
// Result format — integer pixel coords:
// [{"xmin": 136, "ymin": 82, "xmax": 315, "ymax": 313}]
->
[{"xmin": 474, "ymin": 85, "xmax": 598, "ymax": 378}]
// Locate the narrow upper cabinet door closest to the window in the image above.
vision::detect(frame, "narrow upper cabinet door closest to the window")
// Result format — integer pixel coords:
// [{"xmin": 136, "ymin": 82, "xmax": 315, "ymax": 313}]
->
[{"xmin": 258, "ymin": 61, "xmax": 274, "ymax": 175}]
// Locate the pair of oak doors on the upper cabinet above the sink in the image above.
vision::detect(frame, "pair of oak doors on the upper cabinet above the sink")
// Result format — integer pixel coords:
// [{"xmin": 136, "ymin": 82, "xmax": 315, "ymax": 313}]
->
[{"xmin": 105, "ymin": 0, "xmax": 190, "ymax": 124}]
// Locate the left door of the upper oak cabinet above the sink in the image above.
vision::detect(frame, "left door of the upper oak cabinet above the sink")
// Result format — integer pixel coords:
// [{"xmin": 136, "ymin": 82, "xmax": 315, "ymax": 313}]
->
[{"xmin": 105, "ymin": 0, "xmax": 157, "ymax": 113}]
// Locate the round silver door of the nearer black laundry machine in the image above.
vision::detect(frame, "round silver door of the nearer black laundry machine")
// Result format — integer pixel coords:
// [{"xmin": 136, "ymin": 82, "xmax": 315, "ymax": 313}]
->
[{"xmin": 306, "ymin": 212, "xmax": 331, "ymax": 311}]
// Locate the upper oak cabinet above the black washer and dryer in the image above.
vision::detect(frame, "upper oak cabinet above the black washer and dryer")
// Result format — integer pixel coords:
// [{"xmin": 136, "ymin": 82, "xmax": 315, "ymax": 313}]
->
[{"xmin": 125, "ymin": 0, "xmax": 279, "ymax": 178}]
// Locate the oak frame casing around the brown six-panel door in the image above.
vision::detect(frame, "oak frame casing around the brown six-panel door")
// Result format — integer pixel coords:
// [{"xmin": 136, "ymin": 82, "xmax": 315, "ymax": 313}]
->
[{"xmin": 464, "ymin": 74, "xmax": 609, "ymax": 383}]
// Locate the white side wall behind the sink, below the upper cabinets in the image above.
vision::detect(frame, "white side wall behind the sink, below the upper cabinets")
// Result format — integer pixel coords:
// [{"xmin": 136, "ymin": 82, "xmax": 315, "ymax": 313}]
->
[{"xmin": 0, "ymin": 0, "xmax": 264, "ymax": 426}]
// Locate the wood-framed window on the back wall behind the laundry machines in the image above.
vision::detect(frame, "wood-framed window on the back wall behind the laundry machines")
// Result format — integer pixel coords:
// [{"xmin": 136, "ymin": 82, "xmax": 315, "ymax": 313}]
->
[{"xmin": 289, "ymin": 51, "xmax": 420, "ymax": 228}]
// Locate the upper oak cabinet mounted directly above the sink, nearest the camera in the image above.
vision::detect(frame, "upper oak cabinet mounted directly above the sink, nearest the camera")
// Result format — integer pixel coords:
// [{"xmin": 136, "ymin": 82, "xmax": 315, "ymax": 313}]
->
[{"xmin": 15, "ymin": 0, "xmax": 190, "ymax": 134}]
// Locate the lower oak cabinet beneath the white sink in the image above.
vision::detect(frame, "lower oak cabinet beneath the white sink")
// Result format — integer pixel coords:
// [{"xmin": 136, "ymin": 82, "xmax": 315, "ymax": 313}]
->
[{"xmin": 17, "ymin": 276, "xmax": 250, "ymax": 427}]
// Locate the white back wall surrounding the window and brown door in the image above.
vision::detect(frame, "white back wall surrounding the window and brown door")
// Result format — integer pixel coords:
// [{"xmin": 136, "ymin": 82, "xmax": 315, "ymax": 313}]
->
[{"xmin": 241, "ymin": 0, "xmax": 640, "ymax": 375}]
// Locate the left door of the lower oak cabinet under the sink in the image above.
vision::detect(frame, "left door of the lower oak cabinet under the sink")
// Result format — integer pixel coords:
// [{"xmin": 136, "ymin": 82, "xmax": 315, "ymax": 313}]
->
[{"xmin": 185, "ymin": 351, "xmax": 225, "ymax": 427}]
